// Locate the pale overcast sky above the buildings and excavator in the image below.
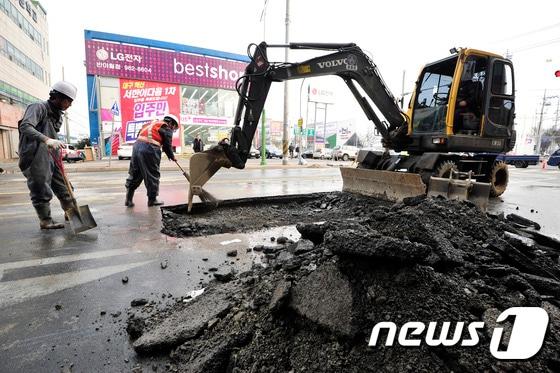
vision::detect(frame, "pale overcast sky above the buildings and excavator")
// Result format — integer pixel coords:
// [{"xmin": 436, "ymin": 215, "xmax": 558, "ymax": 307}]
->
[{"xmin": 41, "ymin": 0, "xmax": 560, "ymax": 141}]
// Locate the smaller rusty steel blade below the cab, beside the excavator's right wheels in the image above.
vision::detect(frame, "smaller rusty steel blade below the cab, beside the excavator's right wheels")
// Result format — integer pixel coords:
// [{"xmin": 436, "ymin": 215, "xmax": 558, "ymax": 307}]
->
[{"xmin": 428, "ymin": 176, "xmax": 490, "ymax": 211}]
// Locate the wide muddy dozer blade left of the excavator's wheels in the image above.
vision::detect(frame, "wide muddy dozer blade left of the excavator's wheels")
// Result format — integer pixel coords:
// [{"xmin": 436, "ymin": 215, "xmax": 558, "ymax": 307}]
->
[{"xmin": 340, "ymin": 167, "xmax": 426, "ymax": 202}]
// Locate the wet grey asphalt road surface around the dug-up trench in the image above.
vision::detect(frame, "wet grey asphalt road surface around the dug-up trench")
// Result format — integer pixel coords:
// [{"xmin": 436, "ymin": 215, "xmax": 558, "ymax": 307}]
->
[{"xmin": 0, "ymin": 163, "xmax": 560, "ymax": 372}]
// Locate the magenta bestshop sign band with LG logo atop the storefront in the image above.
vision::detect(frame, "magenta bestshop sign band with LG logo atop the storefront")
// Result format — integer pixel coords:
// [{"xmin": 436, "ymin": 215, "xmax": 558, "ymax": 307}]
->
[{"xmin": 86, "ymin": 40, "xmax": 246, "ymax": 89}]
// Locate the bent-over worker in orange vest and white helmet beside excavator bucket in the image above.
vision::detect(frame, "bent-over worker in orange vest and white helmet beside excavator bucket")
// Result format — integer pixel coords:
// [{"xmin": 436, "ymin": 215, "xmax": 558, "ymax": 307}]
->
[{"xmin": 124, "ymin": 114, "xmax": 179, "ymax": 207}]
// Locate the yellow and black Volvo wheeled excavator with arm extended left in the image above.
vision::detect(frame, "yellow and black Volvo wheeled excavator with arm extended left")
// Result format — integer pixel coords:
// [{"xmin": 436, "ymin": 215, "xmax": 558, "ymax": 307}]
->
[{"xmin": 188, "ymin": 42, "xmax": 516, "ymax": 211}]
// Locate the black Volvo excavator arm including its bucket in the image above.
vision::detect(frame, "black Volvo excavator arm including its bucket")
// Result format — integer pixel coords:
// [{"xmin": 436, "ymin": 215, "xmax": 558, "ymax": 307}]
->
[{"xmin": 188, "ymin": 42, "xmax": 409, "ymax": 210}]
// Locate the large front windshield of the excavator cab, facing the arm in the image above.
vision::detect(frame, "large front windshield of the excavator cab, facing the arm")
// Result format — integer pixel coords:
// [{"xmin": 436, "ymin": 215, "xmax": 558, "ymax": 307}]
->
[{"xmin": 412, "ymin": 57, "xmax": 457, "ymax": 133}]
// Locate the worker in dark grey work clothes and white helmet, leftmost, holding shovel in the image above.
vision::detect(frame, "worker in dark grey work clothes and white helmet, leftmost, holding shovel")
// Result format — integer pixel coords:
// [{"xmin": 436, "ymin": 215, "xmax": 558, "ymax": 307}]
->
[{"xmin": 18, "ymin": 81, "xmax": 77, "ymax": 229}]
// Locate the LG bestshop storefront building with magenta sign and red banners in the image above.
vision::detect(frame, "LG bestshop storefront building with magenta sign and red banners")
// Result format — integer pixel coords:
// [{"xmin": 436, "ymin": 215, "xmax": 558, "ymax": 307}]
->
[{"xmin": 85, "ymin": 30, "xmax": 249, "ymax": 154}]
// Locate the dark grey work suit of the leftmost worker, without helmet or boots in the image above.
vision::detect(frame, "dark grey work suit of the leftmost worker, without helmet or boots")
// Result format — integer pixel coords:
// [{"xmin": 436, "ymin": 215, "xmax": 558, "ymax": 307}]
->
[{"xmin": 18, "ymin": 101, "xmax": 71, "ymax": 207}]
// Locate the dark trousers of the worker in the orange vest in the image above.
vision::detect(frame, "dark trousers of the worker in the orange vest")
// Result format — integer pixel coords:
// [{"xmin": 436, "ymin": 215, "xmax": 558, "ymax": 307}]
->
[{"xmin": 125, "ymin": 141, "xmax": 161, "ymax": 199}]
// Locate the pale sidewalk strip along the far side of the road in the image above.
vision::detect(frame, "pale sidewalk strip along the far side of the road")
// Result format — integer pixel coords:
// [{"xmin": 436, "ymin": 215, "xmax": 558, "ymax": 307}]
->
[{"xmin": 0, "ymin": 157, "xmax": 332, "ymax": 174}]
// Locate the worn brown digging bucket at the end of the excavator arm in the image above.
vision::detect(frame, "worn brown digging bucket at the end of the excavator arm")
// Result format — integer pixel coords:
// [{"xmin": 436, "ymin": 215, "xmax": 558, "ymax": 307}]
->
[{"xmin": 188, "ymin": 148, "xmax": 231, "ymax": 212}]
